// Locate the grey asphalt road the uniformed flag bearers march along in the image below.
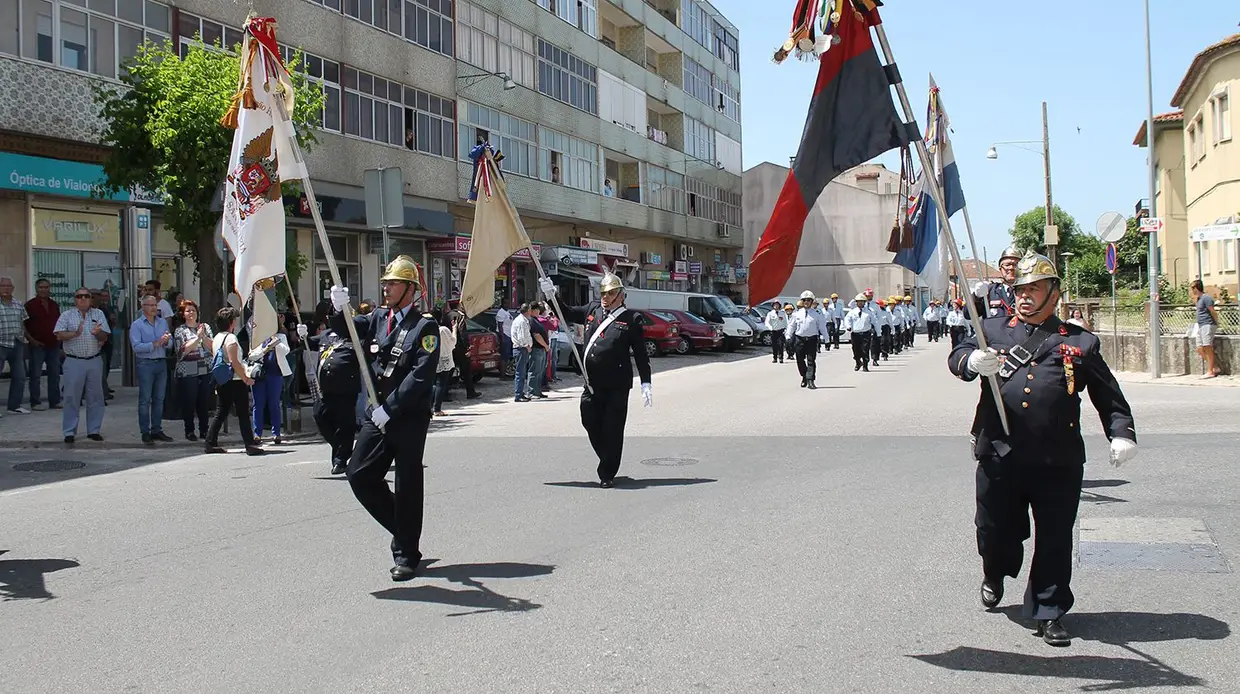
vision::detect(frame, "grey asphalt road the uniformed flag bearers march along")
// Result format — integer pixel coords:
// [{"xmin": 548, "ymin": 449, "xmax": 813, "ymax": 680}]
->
[{"xmin": 0, "ymin": 345, "xmax": 1240, "ymax": 693}]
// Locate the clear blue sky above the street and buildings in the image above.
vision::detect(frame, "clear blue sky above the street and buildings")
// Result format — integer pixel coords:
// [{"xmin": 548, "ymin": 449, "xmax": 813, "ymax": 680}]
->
[{"xmin": 713, "ymin": 0, "xmax": 1240, "ymax": 263}]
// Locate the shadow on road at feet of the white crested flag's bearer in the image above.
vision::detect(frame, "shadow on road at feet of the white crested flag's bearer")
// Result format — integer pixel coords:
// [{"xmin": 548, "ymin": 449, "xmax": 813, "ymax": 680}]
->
[{"xmin": 371, "ymin": 559, "xmax": 556, "ymax": 617}]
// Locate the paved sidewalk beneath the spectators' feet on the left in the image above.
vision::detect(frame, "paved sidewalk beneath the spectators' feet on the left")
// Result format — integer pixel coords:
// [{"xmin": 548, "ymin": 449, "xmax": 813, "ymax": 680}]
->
[{"xmin": 0, "ymin": 382, "xmax": 319, "ymax": 452}]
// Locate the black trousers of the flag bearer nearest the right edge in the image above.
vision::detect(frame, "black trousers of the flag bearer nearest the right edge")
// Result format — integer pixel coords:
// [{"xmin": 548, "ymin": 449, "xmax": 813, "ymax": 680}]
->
[{"xmin": 973, "ymin": 456, "xmax": 1085, "ymax": 620}]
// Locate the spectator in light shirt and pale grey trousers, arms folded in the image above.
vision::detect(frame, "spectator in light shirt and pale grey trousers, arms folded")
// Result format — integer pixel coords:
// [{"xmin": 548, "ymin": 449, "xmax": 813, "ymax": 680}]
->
[{"xmin": 55, "ymin": 286, "xmax": 112, "ymax": 444}]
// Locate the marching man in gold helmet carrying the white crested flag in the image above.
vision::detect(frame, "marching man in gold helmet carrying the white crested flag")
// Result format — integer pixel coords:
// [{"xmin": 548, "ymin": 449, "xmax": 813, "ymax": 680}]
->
[{"xmin": 329, "ymin": 255, "xmax": 439, "ymax": 581}]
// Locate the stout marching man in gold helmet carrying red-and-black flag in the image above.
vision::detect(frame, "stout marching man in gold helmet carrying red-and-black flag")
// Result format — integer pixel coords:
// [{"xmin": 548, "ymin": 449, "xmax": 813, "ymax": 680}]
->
[{"xmin": 947, "ymin": 252, "xmax": 1137, "ymax": 646}]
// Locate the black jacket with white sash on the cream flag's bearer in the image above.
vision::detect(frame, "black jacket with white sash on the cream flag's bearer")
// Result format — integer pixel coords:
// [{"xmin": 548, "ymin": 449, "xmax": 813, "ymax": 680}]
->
[{"xmin": 563, "ymin": 301, "xmax": 650, "ymax": 390}]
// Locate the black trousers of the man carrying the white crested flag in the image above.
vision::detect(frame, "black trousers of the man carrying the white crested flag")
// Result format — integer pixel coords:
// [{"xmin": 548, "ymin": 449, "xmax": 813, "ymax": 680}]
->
[{"xmin": 347, "ymin": 409, "xmax": 430, "ymax": 568}]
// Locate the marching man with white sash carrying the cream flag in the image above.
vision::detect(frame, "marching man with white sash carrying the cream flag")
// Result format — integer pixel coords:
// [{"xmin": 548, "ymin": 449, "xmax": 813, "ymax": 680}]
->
[{"xmin": 538, "ymin": 273, "xmax": 652, "ymax": 490}]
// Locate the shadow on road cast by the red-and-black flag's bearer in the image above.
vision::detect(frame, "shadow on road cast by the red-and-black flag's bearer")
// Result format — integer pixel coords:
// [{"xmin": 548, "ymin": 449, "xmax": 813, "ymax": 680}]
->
[{"xmin": 909, "ymin": 605, "xmax": 1231, "ymax": 692}]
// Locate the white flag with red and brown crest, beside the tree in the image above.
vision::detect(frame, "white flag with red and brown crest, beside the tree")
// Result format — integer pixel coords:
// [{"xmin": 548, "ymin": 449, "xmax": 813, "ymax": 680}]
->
[{"xmin": 222, "ymin": 17, "xmax": 305, "ymax": 345}]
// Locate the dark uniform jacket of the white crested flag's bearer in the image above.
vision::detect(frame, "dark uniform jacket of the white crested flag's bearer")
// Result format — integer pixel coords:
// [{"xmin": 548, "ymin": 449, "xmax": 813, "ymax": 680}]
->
[{"xmin": 329, "ymin": 306, "xmax": 439, "ymax": 420}]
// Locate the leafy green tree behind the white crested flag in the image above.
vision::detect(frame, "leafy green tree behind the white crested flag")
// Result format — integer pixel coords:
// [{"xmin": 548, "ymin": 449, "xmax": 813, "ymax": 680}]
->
[{"xmin": 94, "ymin": 37, "xmax": 324, "ymax": 310}]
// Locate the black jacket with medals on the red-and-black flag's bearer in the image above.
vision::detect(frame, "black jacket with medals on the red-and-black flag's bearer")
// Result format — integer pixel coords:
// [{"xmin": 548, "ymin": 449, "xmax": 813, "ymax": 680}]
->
[{"xmin": 947, "ymin": 316, "xmax": 1137, "ymax": 465}]
